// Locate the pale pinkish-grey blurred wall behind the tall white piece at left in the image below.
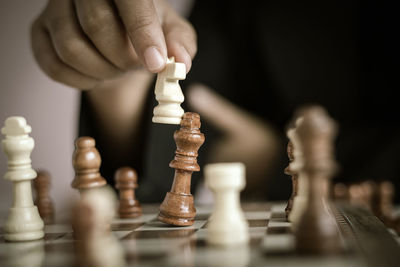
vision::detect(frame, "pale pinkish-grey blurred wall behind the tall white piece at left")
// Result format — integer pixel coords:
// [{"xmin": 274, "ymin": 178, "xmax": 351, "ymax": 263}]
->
[{"xmin": 0, "ymin": 0, "xmax": 79, "ymax": 217}]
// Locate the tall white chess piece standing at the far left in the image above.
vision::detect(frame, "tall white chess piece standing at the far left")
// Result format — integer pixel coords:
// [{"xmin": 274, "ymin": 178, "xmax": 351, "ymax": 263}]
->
[{"xmin": 1, "ymin": 117, "xmax": 44, "ymax": 241}]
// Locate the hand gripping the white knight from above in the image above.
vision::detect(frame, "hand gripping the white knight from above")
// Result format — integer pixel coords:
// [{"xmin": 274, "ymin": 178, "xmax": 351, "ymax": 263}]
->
[{"xmin": 31, "ymin": 0, "xmax": 197, "ymax": 89}]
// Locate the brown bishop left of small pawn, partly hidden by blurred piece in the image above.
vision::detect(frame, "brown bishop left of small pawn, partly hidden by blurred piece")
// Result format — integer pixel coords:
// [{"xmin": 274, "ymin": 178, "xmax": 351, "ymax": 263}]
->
[{"xmin": 71, "ymin": 136, "xmax": 107, "ymax": 191}]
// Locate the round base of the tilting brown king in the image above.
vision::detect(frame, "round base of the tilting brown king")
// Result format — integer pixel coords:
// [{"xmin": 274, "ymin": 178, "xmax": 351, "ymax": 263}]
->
[{"xmin": 158, "ymin": 192, "xmax": 196, "ymax": 226}]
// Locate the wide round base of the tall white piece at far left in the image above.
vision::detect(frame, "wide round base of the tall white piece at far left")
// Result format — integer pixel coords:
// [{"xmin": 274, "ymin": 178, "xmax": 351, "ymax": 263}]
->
[{"xmin": 4, "ymin": 206, "xmax": 44, "ymax": 241}]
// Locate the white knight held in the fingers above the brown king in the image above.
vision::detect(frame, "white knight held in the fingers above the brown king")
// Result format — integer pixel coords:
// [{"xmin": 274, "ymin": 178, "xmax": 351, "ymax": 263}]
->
[{"xmin": 152, "ymin": 57, "xmax": 186, "ymax": 124}]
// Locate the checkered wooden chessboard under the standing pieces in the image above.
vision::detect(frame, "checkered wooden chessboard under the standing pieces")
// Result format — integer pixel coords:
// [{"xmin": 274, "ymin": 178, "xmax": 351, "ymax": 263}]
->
[{"xmin": 0, "ymin": 203, "xmax": 400, "ymax": 267}]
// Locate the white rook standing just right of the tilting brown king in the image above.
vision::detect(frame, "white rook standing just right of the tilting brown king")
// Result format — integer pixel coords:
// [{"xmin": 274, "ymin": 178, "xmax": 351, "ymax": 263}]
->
[{"xmin": 204, "ymin": 163, "xmax": 249, "ymax": 246}]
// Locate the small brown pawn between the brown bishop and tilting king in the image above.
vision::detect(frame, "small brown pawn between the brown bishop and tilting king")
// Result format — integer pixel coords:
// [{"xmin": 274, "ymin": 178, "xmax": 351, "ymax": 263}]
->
[{"xmin": 114, "ymin": 167, "xmax": 142, "ymax": 218}]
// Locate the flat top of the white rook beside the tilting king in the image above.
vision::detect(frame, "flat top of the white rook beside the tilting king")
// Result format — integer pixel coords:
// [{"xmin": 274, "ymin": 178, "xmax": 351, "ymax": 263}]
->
[{"xmin": 204, "ymin": 162, "xmax": 246, "ymax": 191}]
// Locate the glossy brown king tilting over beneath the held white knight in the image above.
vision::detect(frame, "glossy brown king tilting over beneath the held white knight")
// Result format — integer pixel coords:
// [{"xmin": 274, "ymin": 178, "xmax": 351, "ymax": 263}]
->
[{"xmin": 158, "ymin": 112, "xmax": 205, "ymax": 226}]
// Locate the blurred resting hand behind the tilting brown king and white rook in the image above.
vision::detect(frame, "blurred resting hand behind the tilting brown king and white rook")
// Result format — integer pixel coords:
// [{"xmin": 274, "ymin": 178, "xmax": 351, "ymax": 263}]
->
[{"xmin": 185, "ymin": 85, "xmax": 283, "ymax": 193}]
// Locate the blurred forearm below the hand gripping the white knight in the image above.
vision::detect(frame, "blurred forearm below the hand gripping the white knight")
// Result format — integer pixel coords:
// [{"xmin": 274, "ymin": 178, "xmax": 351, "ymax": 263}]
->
[{"xmin": 87, "ymin": 70, "xmax": 153, "ymax": 150}]
